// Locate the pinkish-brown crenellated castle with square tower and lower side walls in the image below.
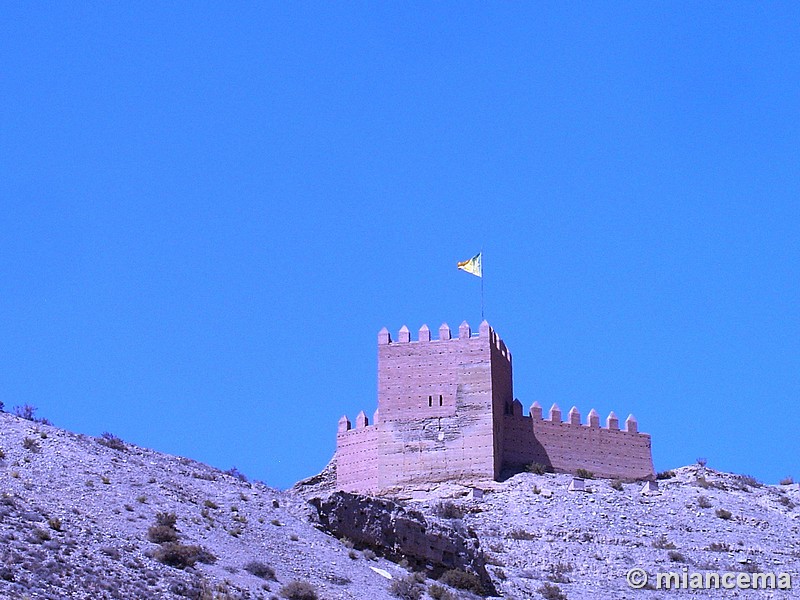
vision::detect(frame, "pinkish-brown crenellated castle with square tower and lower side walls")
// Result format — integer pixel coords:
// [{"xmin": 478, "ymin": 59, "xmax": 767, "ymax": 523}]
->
[{"xmin": 336, "ymin": 321, "xmax": 653, "ymax": 493}]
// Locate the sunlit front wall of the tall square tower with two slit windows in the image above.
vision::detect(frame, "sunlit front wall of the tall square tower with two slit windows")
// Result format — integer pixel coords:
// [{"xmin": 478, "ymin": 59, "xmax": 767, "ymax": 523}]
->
[{"xmin": 378, "ymin": 323, "xmax": 507, "ymax": 489}]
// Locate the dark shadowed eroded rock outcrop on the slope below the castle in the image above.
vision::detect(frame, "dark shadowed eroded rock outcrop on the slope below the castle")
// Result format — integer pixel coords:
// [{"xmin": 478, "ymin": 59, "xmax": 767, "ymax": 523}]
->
[{"xmin": 311, "ymin": 492, "xmax": 495, "ymax": 594}]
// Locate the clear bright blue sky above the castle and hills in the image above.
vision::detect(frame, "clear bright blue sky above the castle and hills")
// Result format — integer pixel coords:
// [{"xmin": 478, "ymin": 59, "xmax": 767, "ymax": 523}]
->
[{"xmin": 0, "ymin": 2, "xmax": 800, "ymax": 487}]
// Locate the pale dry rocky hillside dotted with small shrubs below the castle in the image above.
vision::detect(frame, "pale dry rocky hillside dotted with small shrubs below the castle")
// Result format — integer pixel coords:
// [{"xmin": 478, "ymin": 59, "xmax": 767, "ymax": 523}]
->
[{"xmin": 0, "ymin": 413, "xmax": 800, "ymax": 600}]
